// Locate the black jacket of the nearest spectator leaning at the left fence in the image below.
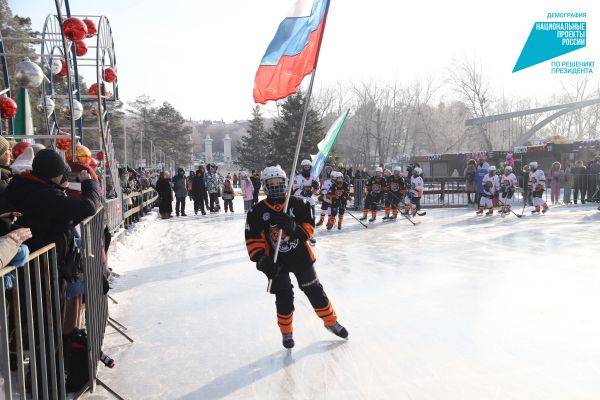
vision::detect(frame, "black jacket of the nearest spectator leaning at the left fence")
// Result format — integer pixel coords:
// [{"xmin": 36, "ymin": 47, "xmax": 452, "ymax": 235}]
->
[{"xmin": 4, "ymin": 173, "xmax": 102, "ymax": 252}]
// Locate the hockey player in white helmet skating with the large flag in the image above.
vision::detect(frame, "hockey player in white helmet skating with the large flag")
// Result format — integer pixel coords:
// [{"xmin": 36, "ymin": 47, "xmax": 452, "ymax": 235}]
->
[{"xmin": 246, "ymin": 166, "xmax": 348, "ymax": 349}]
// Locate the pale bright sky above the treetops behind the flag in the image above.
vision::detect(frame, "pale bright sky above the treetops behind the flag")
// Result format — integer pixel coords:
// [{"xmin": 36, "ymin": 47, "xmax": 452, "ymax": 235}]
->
[{"xmin": 9, "ymin": 0, "xmax": 600, "ymax": 121}]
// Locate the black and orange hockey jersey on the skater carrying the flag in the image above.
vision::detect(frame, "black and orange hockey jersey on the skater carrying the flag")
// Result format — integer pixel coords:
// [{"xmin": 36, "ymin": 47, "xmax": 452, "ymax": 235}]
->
[{"xmin": 246, "ymin": 196, "xmax": 316, "ymax": 264}]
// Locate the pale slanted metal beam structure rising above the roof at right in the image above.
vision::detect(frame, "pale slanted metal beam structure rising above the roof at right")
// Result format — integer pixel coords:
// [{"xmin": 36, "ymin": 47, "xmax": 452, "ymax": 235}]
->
[{"xmin": 465, "ymin": 98, "xmax": 600, "ymax": 151}]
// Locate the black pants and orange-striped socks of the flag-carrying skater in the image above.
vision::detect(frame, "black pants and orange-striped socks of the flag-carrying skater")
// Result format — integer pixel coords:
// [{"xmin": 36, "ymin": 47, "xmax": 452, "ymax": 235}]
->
[{"xmin": 271, "ymin": 263, "xmax": 337, "ymax": 333}]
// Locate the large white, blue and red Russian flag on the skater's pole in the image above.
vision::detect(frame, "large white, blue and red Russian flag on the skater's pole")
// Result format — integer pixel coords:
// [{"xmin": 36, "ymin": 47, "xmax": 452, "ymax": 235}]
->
[{"xmin": 254, "ymin": 0, "xmax": 330, "ymax": 104}]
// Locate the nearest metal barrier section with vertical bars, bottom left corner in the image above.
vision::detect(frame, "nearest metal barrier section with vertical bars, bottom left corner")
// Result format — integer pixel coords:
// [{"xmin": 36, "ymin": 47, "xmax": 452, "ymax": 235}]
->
[{"xmin": 0, "ymin": 244, "xmax": 66, "ymax": 400}]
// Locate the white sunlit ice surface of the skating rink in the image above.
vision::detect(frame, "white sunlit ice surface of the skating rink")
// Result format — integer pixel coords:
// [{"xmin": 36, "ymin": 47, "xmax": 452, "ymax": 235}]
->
[{"xmin": 90, "ymin": 198, "xmax": 600, "ymax": 400}]
